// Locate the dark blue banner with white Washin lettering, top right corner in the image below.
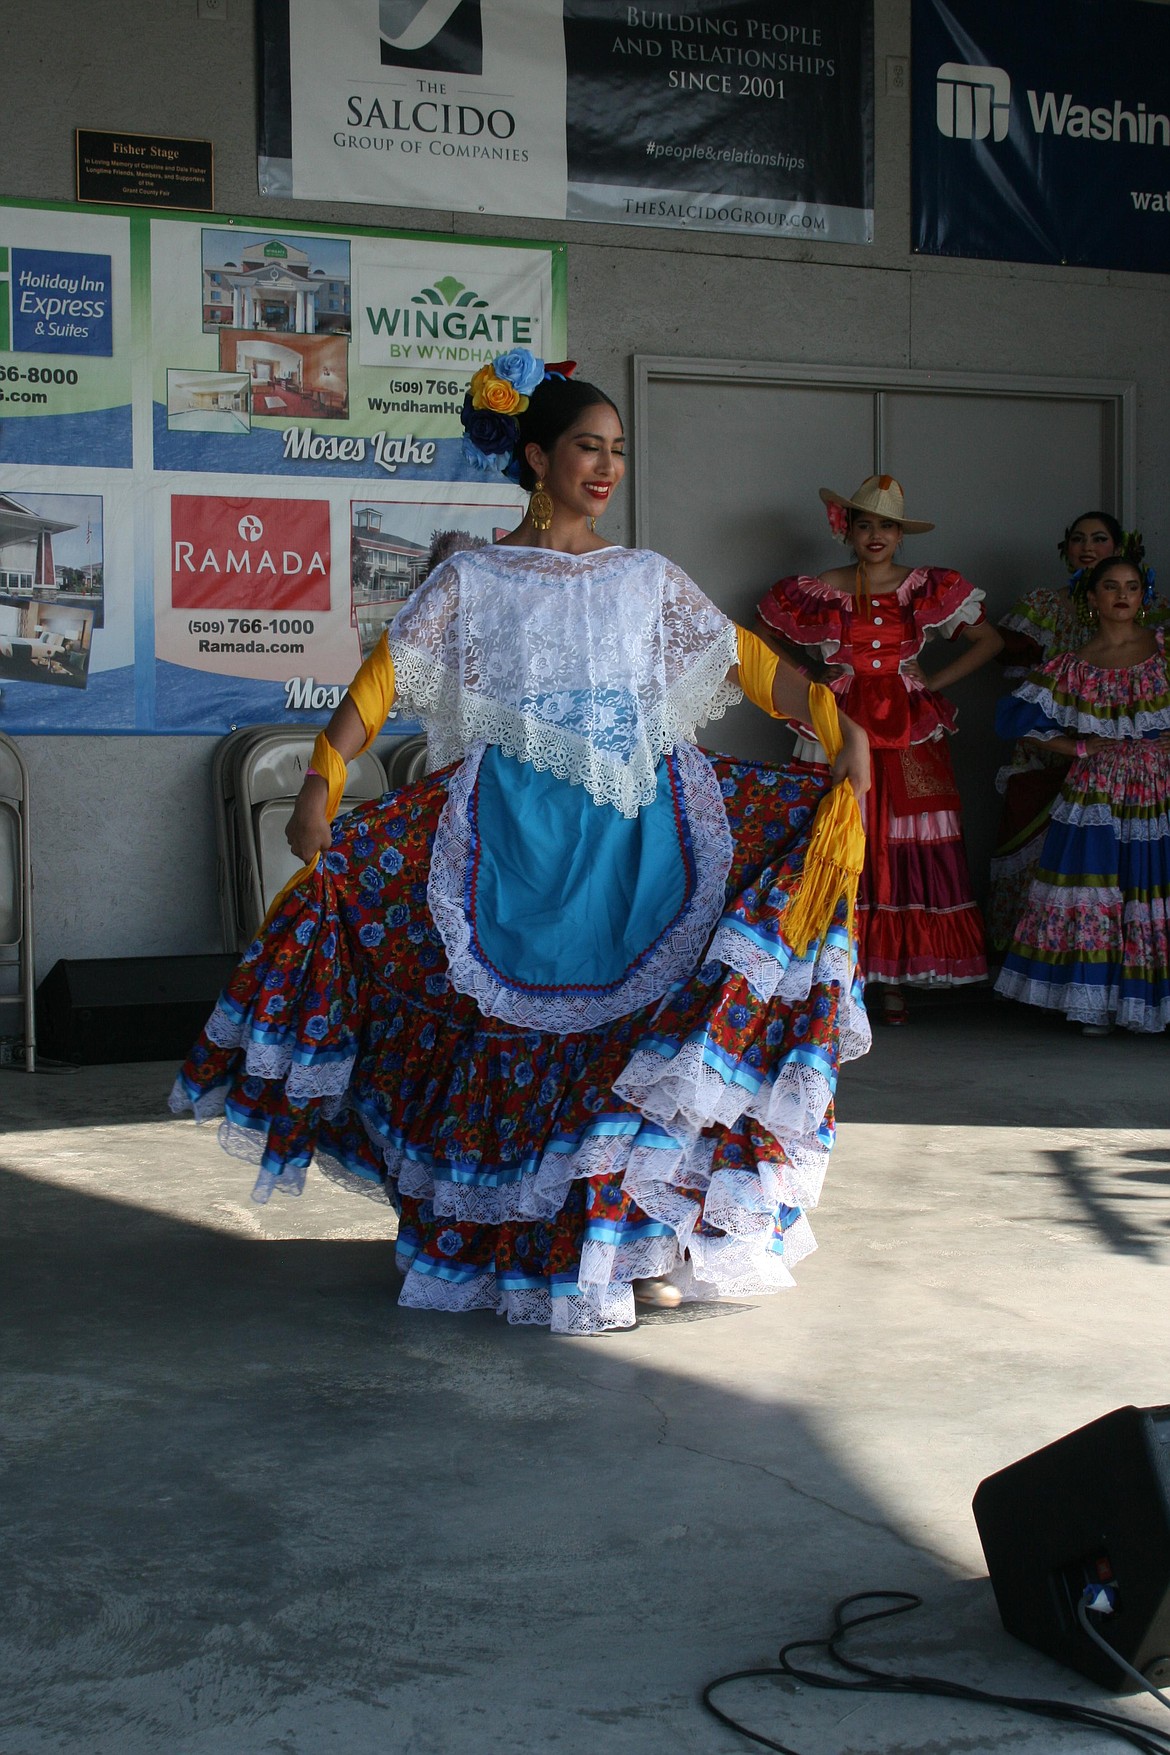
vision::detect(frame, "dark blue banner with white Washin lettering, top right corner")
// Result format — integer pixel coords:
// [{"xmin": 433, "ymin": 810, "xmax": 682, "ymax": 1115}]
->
[{"xmin": 912, "ymin": 0, "xmax": 1170, "ymax": 274}]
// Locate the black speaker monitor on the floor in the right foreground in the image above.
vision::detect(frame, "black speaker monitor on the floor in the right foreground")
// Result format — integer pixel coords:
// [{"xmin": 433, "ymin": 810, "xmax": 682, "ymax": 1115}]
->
[{"xmin": 972, "ymin": 1408, "xmax": 1170, "ymax": 1694}]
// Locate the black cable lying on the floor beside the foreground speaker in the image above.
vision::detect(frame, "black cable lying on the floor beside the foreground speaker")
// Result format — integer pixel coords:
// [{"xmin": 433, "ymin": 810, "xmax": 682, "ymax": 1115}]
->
[{"xmin": 702, "ymin": 1590, "xmax": 1170, "ymax": 1755}]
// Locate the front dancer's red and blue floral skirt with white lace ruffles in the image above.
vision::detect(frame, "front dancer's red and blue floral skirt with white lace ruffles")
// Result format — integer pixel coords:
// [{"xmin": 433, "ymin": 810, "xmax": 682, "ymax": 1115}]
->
[{"xmin": 172, "ymin": 756, "xmax": 868, "ymax": 1334}]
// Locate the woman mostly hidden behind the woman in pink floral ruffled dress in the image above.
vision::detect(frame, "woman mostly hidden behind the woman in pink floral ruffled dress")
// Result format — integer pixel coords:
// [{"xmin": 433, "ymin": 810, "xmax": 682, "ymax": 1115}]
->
[{"xmin": 988, "ymin": 512, "xmax": 1170, "ymax": 955}]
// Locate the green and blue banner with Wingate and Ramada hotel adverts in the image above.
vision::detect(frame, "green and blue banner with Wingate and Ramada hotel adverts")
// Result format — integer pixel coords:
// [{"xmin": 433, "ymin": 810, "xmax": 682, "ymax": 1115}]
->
[{"xmin": 0, "ymin": 202, "xmax": 567, "ymax": 734}]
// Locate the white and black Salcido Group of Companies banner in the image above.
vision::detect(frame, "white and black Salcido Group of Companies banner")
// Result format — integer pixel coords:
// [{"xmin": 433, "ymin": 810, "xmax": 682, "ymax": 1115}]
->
[{"xmin": 256, "ymin": 0, "xmax": 874, "ymax": 244}]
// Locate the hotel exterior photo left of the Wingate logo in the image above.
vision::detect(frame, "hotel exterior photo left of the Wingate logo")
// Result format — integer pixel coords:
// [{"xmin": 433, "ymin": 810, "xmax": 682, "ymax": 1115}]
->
[{"xmin": 203, "ymin": 230, "xmax": 349, "ymax": 335}]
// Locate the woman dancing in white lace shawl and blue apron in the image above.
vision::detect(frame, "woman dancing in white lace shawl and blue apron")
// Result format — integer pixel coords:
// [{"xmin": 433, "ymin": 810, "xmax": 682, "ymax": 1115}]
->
[{"xmin": 174, "ymin": 349, "xmax": 868, "ymax": 1334}]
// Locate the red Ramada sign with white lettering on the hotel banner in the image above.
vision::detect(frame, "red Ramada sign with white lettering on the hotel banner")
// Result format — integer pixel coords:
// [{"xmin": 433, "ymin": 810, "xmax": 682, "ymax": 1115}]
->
[{"xmin": 170, "ymin": 493, "xmax": 330, "ymax": 611}]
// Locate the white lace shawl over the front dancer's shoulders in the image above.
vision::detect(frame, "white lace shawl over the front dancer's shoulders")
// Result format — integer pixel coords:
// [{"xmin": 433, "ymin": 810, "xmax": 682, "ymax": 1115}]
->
[{"xmin": 389, "ymin": 544, "xmax": 740, "ymax": 816}]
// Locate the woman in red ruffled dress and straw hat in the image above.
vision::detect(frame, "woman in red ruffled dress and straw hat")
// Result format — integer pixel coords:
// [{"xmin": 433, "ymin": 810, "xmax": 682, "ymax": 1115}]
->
[{"xmin": 760, "ymin": 476, "xmax": 1002, "ymax": 1023}]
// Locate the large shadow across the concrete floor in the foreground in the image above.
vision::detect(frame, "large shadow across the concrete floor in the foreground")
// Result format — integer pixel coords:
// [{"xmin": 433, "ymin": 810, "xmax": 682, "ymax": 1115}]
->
[{"xmin": 0, "ymin": 1151, "xmax": 1115, "ymax": 1755}]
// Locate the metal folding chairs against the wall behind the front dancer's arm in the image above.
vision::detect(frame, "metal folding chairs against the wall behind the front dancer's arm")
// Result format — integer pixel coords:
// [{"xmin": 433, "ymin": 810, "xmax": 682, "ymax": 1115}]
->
[{"xmin": 212, "ymin": 725, "xmax": 426, "ymax": 951}]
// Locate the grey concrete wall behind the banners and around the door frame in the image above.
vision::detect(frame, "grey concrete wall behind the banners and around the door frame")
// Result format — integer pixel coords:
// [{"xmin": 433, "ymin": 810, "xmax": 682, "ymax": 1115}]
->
[{"xmin": 0, "ymin": 0, "xmax": 1170, "ymax": 972}]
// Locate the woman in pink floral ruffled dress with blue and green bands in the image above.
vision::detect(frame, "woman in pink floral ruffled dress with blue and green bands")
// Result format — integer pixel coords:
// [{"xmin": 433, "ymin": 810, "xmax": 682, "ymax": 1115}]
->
[{"xmin": 996, "ymin": 556, "xmax": 1170, "ymax": 1035}]
